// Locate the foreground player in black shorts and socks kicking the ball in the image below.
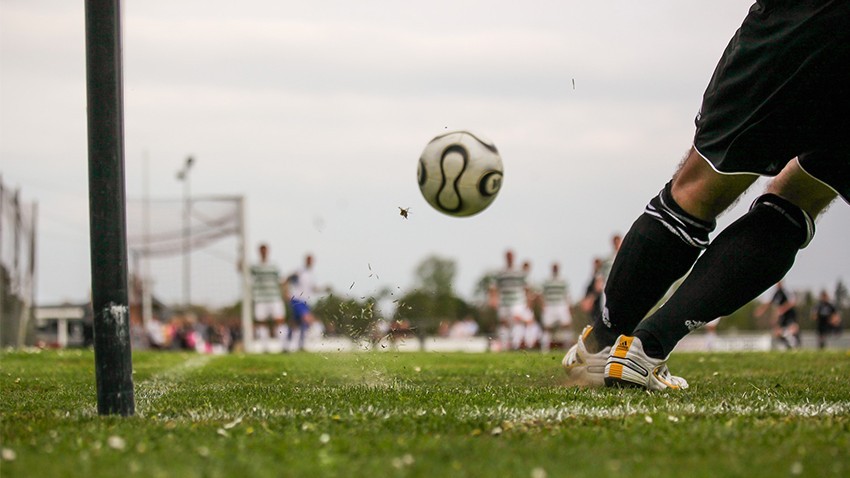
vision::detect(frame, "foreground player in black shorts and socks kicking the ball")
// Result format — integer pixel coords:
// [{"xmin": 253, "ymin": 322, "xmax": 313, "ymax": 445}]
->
[{"xmin": 564, "ymin": 0, "xmax": 850, "ymax": 390}]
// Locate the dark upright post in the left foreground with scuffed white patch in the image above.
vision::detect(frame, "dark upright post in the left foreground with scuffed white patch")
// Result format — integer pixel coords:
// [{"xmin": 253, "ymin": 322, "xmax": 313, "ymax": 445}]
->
[{"xmin": 85, "ymin": 0, "xmax": 135, "ymax": 416}]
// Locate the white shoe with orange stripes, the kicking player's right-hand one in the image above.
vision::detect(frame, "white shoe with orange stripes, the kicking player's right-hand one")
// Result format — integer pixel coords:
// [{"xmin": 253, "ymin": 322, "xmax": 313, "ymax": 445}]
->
[{"xmin": 604, "ymin": 335, "xmax": 688, "ymax": 390}]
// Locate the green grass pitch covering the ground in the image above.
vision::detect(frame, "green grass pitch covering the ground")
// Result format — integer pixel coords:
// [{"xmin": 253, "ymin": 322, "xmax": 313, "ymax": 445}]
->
[{"xmin": 0, "ymin": 351, "xmax": 850, "ymax": 478}]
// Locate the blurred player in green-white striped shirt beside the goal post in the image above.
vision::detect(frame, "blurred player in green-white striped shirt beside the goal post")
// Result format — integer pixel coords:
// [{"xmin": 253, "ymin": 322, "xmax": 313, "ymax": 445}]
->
[{"xmin": 251, "ymin": 244, "xmax": 286, "ymax": 350}]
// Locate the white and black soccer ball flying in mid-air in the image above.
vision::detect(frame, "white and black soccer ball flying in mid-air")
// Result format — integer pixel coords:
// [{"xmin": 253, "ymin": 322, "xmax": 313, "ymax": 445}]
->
[{"xmin": 417, "ymin": 131, "xmax": 503, "ymax": 217}]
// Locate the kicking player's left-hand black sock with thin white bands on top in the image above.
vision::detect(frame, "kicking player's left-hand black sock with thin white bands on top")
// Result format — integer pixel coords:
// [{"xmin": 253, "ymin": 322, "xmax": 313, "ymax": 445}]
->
[{"xmin": 588, "ymin": 183, "xmax": 715, "ymax": 351}]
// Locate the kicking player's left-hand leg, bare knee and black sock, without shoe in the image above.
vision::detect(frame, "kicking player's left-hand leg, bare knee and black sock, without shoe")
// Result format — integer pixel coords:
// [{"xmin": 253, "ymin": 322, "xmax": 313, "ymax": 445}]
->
[{"xmin": 587, "ymin": 148, "xmax": 757, "ymax": 351}]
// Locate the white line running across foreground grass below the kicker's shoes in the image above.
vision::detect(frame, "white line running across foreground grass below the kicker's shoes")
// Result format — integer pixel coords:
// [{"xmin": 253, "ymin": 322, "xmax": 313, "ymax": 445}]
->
[{"xmin": 139, "ymin": 401, "xmax": 850, "ymax": 424}]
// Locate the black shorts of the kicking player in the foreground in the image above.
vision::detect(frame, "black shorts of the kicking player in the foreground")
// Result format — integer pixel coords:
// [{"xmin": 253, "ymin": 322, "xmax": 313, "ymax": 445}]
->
[{"xmin": 694, "ymin": 0, "xmax": 850, "ymax": 202}]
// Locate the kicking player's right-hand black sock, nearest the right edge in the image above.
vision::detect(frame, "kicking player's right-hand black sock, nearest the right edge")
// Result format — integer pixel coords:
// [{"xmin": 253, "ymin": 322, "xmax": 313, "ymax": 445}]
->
[{"xmin": 634, "ymin": 194, "xmax": 814, "ymax": 358}]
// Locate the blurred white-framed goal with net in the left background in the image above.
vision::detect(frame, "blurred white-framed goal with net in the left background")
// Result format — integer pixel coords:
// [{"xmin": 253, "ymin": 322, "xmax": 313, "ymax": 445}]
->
[{"xmin": 127, "ymin": 196, "xmax": 250, "ymax": 346}]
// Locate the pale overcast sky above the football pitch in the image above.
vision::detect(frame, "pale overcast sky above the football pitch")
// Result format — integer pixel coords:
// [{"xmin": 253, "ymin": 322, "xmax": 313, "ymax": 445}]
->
[{"xmin": 0, "ymin": 0, "xmax": 850, "ymax": 310}]
